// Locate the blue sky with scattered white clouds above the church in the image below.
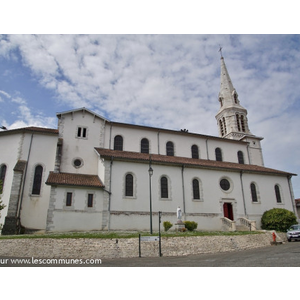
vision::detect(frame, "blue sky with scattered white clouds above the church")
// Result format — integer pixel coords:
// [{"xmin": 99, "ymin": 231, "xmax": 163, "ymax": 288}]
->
[{"xmin": 0, "ymin": 34, "xmax": 300, "ymax": 198}]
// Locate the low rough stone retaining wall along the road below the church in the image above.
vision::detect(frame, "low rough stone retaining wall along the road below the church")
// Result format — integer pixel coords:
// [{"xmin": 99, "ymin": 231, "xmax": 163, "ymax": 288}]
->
[{"xmin": 0, "ymin": 232, "xmax": 286, "ymax": 259}]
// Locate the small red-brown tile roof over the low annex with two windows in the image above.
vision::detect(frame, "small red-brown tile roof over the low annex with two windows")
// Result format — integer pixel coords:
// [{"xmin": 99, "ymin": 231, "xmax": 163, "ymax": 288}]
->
[{"xmin": 46, "ymin": 172, "xmax": 104, "ymax": 188}]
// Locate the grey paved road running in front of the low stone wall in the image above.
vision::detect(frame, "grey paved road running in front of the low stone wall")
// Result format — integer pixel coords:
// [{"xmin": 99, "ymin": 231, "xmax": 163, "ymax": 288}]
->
[{"xmin": 0, "ymin": 242, "xmax": 300, "ymax": 267}]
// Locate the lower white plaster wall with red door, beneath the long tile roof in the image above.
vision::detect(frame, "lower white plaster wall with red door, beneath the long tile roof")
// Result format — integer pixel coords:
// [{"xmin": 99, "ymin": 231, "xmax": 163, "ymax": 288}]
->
[{"xmin": 106, "ymin": 161, "xmax": 293, "ymax": 230}]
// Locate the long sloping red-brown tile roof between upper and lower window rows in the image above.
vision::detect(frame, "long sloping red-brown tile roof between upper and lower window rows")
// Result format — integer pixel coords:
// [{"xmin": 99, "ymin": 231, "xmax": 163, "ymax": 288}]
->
[{"xmin": 95, "ymin": 148, "xmax": 296, "ymax": 176}]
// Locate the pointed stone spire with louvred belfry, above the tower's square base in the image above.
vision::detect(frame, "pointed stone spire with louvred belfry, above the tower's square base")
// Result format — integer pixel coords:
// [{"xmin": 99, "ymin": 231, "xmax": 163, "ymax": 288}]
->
[{"xmin": 216, "ymin": 52, "xmax": 252, "ymax": 140}]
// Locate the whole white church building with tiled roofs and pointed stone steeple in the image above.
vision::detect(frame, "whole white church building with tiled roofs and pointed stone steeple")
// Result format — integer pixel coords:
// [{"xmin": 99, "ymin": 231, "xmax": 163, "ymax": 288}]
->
[{"xmin": 0, "ymin": 57, "xmax": 297, "ymax": 234}]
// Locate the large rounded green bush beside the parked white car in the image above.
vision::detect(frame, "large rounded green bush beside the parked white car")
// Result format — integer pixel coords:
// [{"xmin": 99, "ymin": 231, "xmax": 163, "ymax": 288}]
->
[{"xmin": 261, "ymin": 208, "xmax": 297, "ymax": 232}]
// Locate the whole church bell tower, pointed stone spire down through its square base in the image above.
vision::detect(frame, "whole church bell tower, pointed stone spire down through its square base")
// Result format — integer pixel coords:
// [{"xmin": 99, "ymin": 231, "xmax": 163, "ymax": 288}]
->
[{"xmin": 216, "ymin": 47, "xmax": 263, "ymax": 165}]
